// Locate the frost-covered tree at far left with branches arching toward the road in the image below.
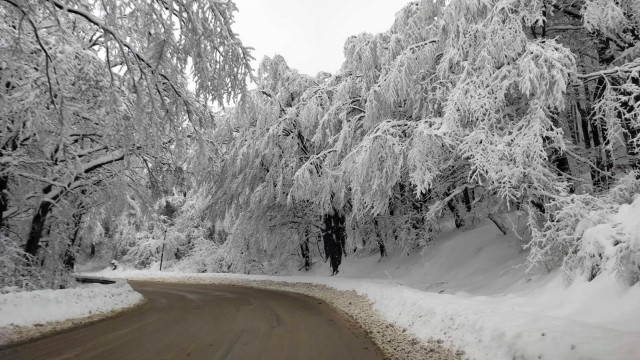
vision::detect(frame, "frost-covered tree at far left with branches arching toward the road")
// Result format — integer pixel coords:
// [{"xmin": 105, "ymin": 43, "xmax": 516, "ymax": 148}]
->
[{"xmin": 0, "ymin": 0, "xmax": 251, "ymax": 286}]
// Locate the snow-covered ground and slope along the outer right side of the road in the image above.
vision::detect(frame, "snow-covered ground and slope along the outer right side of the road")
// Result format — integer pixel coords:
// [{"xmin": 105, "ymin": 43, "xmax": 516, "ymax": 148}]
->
[{"xmin": 94, "ymin": 217, "xmax": 640, "ymax": 360}]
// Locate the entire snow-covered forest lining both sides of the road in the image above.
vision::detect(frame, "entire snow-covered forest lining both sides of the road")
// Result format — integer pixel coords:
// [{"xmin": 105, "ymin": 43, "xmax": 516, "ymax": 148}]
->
[{"xmin": 0, "ymin": 0, "xmax": 640, "ymax": 290}]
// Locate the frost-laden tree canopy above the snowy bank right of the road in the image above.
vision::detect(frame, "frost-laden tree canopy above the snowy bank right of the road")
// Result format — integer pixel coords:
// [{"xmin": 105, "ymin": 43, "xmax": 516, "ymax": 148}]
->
[{"xmin": 206, "ymin": 0, "xmax": 639, "ymax": 280}]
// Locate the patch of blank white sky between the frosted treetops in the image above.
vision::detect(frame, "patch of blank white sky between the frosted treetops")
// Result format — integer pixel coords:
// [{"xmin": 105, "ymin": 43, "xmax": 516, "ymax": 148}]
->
[{"xmin": 233, "ymin": 0, "xmax": 409, "ymax": 75}]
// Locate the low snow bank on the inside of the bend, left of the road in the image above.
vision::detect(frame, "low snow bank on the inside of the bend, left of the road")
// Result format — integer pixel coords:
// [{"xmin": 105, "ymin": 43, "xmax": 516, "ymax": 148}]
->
[{"xmin": 0, "ymin": 281, "xmax": 143, "ymax": 328}]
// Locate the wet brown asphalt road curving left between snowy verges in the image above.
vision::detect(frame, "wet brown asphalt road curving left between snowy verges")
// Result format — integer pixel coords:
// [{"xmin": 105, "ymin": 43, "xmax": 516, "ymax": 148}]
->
[{"xmin": 0, "ymin": 282, "xmax": 382, "ymax": 360}]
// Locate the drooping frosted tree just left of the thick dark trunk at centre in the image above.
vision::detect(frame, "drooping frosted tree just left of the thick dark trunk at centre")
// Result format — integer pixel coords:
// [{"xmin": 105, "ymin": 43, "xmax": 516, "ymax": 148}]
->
[{"xmin": 199, "ymin": 56, "xmax": 330, "ymax": 272}]
